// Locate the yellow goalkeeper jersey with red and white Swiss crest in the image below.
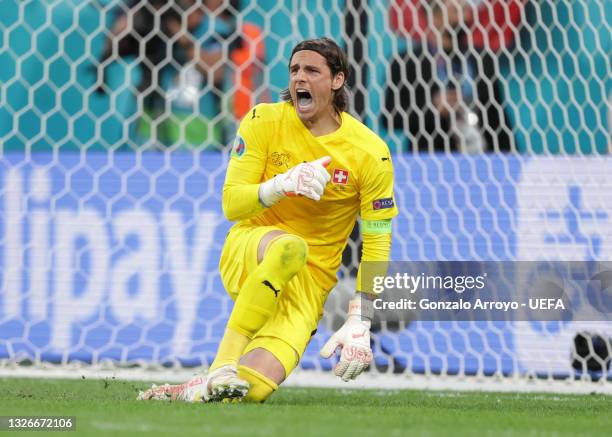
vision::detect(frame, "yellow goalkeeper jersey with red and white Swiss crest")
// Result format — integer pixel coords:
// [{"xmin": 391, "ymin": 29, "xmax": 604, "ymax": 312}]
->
[{"xmin": 223, "ymin": 102, "xmax": 397, "ymax": 290}]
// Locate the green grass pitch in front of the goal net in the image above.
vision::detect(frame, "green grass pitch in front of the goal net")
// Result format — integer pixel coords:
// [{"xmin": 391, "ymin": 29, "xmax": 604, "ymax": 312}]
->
[{"xmin": 0, "ymin": 375, "xmax": 612, "ymax": 437}]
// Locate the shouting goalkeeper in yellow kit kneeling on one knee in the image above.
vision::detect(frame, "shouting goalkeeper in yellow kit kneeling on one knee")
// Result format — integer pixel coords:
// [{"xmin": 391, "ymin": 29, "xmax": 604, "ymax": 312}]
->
[{"xmin": 140, "ymin": 38, "xmax": 397, "ymax": 402}]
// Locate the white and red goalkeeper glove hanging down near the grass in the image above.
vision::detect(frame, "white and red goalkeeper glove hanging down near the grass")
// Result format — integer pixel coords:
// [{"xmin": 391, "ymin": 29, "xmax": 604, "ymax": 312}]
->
[{"xmin": 320, "ymin": 297, "xmax": 373, "ymax": 381}]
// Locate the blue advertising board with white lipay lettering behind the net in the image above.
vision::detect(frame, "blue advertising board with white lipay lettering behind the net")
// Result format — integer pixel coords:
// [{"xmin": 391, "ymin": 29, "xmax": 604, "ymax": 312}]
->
[{"xmin": 0, "ymin": 152, "xmax": 612, "ymax": 373}]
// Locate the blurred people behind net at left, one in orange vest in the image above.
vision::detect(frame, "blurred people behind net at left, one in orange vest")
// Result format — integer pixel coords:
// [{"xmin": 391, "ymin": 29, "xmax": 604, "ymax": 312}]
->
[{"xmin": 96, "ymin": 0, "xmax": 267, "ymax": 148}]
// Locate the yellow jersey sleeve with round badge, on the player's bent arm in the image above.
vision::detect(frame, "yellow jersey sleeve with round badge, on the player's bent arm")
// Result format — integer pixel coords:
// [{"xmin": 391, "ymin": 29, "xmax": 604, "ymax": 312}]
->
[{"xmin": 223, "ymin": 106, "xmax": 267, "ymax": 221}]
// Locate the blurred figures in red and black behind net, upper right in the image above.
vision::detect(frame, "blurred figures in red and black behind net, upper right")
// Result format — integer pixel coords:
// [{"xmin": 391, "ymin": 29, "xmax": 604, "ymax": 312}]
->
[{"xmin": 381, "ymin": 0, "xmax": 524, "ymax": 153}]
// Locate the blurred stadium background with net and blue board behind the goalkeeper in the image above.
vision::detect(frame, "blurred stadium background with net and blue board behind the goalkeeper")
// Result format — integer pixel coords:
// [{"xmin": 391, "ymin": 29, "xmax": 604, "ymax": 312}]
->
[{"xmin": 0, "ymin": 0, "xmax": 612, "ymax": 391}]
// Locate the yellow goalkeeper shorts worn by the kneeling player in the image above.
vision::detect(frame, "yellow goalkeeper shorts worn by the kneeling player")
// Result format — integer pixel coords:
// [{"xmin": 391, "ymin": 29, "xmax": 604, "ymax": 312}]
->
[{"xmin": 219, "ymin": 225, "xmax": 328, "ymax": 376}]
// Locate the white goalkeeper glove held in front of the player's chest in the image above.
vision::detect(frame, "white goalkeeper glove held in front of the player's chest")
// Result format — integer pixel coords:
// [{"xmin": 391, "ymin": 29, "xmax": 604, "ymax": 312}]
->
[{"xmin": 259, "ymin": 156, "xmax": 331, "ymax": 207}]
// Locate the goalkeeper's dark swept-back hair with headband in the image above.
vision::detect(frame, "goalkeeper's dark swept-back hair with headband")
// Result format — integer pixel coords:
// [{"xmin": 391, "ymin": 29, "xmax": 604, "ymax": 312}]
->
[{"xmin": 281, "ymin": 38, "xmax": 350, "ymax": 113}]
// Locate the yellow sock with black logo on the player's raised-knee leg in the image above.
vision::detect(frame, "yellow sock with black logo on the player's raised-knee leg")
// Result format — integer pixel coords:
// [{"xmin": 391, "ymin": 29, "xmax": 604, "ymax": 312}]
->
[{"xmin": 210, "ymin": 234, "xmax": 308, "ymax": 370}]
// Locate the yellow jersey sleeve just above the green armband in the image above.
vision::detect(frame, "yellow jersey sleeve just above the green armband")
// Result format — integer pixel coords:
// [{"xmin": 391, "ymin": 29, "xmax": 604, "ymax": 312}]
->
[{"xmin": 359, "ymin": 149, "xmax": 398, "ymax": 220}]
